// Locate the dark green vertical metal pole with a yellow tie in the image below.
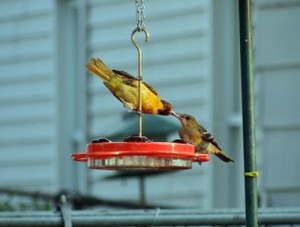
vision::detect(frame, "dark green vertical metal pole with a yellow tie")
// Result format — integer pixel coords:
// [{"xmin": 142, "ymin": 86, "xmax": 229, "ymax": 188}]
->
[{"xmin": 239, "ymin": 0, "xmax": 258, "ymax": 227}]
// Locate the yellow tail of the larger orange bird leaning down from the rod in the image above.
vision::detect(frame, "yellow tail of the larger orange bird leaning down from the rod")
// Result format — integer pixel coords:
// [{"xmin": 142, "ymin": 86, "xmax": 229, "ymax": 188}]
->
[{"xmin": 86, "ymin": 58, "xmax": 115, "ymax": 81}]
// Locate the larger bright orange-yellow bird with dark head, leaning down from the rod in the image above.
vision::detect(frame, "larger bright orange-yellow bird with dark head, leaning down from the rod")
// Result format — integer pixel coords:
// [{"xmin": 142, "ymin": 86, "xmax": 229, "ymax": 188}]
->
[{"xmin": 86, "ymin": 58, "xmax": 178, "ymax": 117}]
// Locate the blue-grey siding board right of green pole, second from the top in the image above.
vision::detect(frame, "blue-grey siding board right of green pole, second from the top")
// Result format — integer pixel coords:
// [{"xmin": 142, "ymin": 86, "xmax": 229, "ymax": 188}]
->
[{"xmin": 259, "ymin": 67, "xmax": 300, "ymax": 127}]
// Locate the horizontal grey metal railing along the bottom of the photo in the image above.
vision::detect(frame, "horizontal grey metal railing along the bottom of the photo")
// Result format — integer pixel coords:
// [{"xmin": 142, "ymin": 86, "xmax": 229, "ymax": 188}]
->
[{"xmin": 0, "ymin": 208, "xmax": 300, "ymax": 227}]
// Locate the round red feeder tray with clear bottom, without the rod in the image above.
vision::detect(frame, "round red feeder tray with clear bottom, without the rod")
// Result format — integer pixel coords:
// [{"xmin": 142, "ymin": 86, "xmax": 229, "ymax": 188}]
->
[{"xmin": 72, "ymin": 139, "xmax": 209, "ymax": 170}]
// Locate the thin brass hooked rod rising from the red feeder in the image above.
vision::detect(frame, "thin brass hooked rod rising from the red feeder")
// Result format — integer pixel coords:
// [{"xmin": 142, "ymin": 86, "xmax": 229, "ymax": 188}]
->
[{"xmin": 131, "ymin": 28, "xmax": 149, "ymax": 137}]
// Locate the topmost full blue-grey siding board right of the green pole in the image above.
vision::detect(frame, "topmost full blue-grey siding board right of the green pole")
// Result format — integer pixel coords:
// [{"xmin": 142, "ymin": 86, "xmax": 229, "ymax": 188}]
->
[{"xmin": 256, "ymin": 1, "xmax": 300, "ymax": 70}]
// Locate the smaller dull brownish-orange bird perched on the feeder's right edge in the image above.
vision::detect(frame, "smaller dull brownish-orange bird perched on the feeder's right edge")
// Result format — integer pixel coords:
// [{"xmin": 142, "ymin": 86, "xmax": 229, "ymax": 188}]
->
[{"xmin": 177, "ymin": 114, "xmax": 234, "ymax": 162}]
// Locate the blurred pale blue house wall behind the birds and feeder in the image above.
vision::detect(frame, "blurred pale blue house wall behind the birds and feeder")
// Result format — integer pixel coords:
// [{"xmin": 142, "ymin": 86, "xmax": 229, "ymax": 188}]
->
[{"xmin": 0, "ymin": 0, "xmax": 300, "ymax": 210}]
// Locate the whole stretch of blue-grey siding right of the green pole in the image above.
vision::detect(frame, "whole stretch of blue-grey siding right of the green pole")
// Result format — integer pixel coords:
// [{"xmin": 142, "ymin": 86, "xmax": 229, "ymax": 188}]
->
[{"xmin": 254, "ymin": 0, "xmax": 300, "ymax": 207}]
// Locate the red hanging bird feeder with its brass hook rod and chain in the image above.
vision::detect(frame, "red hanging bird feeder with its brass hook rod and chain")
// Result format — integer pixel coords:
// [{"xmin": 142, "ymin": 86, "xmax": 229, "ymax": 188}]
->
[{"xmin": 72, "ymin": 0, "xmax": 209, "ymax": 170}]
